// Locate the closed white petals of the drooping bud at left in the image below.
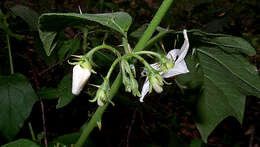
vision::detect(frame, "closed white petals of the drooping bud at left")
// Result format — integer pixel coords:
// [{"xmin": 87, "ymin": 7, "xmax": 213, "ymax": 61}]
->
[{"xmin": 72, "ymin": 64, "xmax": 91, "ymax": 95}]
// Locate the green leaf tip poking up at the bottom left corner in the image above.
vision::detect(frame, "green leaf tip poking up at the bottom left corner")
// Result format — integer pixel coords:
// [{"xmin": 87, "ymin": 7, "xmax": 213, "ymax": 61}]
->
[{"xmin": 2, "ymin": 139, "xmax": 40, "ymax": 147}]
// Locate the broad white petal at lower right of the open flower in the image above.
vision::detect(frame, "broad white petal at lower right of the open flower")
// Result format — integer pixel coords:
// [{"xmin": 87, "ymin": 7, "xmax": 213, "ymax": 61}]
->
[{"xmin": 162, "ymin": 60, "xmax": 189, "ymax": 78}]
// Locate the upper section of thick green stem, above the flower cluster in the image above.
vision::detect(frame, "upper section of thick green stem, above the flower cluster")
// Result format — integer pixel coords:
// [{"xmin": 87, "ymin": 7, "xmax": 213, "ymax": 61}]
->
[{"xmin": 134, "ymin": 0, "xmax": 174, "ymax": 52}]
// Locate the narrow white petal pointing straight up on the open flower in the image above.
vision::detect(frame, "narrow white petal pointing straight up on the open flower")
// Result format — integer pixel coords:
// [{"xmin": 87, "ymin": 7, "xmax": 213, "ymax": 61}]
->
[{"xmin": 175, "ymin": 30, "xmax": 190, "ymax": 63}]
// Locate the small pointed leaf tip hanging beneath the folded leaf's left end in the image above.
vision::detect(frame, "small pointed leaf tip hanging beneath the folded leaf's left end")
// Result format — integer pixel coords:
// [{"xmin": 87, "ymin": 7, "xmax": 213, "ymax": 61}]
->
[{"xmin": 39, "ymin": 30, "xmax": 57, "ymax": 56}]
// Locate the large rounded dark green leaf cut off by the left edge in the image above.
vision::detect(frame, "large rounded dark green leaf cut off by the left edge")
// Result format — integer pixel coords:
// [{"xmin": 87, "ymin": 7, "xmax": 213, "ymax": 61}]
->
[{"xmin": 0, "ymin": 74, "xmax": 37, "ymax": 140}]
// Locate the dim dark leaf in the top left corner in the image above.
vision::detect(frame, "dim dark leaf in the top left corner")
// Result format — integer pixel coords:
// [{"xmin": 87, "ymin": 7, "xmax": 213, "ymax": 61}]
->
[{"xmin": 10, "ymin": 5, "xmax": 39, "ymax": 30}]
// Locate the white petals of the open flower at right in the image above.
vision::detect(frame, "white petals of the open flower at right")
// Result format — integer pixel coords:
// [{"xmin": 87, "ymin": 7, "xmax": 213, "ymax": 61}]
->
[{"xmin": 140, "ymin": 30, "xmax": 189, "ymax": 102}]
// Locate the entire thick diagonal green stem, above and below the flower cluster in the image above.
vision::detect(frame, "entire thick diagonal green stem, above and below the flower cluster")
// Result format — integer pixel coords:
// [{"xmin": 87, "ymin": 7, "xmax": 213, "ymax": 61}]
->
[{"xmin": 75, "ymin": 0, "xmax": 173, "ymax": 147}]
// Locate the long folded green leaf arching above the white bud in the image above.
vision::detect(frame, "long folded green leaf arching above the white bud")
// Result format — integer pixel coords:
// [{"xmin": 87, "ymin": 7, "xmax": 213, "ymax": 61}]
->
[{"xmin": 39, "ymin": 12, "xmax": 132, "ymax": 35}]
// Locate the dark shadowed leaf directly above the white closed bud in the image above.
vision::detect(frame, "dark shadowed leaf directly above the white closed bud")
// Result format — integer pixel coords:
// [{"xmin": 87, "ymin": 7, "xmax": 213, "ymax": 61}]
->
[{"xmin": 58, "ymin": 38, "xmax": 80, "ymax": 62}]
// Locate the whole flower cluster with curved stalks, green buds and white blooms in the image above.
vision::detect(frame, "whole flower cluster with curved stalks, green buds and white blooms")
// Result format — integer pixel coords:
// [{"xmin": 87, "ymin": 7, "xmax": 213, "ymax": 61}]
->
[{"xmin": 70, "ymin": 30, "xmax": 189, "ymax": 106}]
